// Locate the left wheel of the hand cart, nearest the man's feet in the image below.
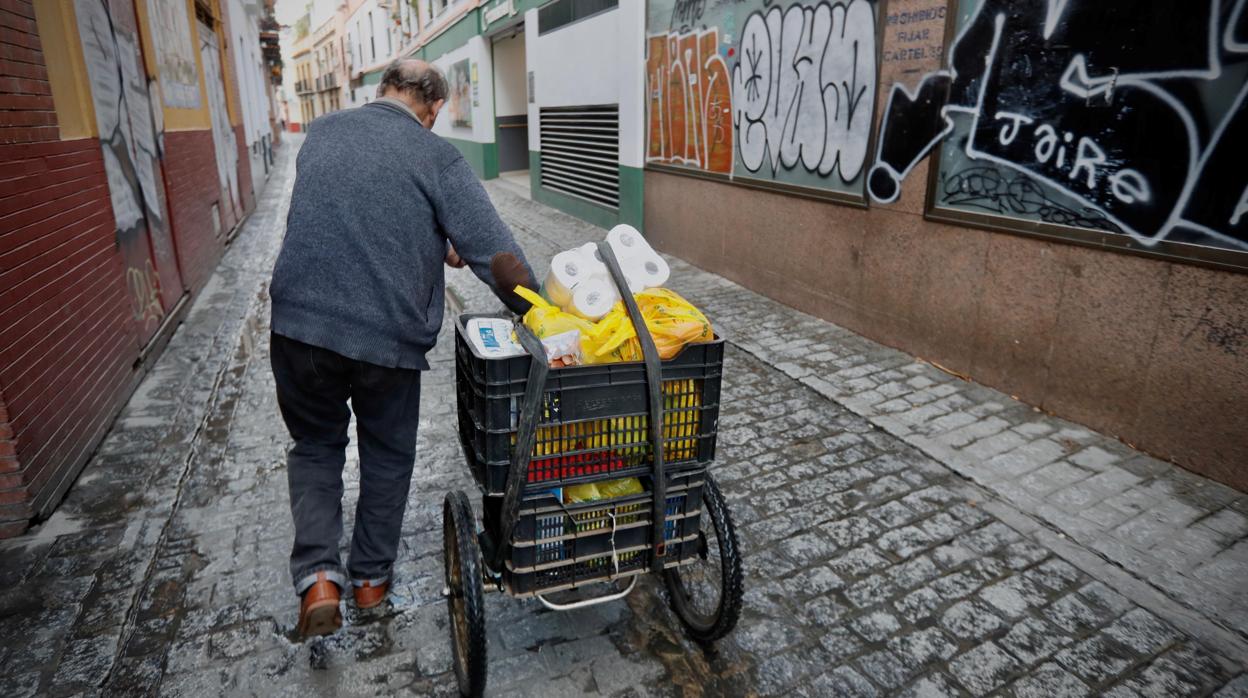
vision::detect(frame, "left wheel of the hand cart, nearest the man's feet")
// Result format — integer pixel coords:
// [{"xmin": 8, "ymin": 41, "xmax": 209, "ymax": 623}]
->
[{"xmin": 442, "ymin": 491, "xmax": 485, "ymax": 697}]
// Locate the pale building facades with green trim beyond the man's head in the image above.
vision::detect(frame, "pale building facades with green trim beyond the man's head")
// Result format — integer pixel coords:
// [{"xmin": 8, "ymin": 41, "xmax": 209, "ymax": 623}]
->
[{"xmin": 277, "ymin": 0, "xmax": 645, "ymax": 226}]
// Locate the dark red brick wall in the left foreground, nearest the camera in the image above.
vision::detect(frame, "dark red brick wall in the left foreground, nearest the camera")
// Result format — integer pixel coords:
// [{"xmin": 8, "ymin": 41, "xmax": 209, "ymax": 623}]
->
[{"xmin": 0, "ymin": 0, "xmax": 139, "ymax": 537}]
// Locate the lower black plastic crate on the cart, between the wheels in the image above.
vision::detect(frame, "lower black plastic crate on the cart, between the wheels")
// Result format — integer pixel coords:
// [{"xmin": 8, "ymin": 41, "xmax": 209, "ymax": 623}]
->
[{"xmin": 504, "ymin": 471, "xmax": 704, "ymax": 574}]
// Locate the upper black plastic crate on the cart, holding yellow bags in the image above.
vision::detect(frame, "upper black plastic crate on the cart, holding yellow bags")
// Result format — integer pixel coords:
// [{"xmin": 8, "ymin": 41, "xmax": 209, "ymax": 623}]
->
[{"xmin": 456, "ymin": 315, "xmax": 724, "ymax": 494}]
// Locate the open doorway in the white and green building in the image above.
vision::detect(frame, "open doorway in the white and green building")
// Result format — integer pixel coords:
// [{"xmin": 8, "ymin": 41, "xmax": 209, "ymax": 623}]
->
[{"xmin": 494, "ymin": 29, "xmax": 529, "ymax": 181}]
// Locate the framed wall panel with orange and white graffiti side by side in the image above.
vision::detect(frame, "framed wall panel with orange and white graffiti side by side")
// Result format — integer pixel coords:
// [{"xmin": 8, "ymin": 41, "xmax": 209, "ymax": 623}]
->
[{"xmin": 646, "ymin": 0, "xmax": 877, "ymax": 191}]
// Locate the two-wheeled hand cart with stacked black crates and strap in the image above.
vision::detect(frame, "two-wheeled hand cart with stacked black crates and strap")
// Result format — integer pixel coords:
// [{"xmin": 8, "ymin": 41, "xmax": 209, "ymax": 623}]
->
[{"xmin": 442, "ymin": 242, "xmax": 743, "ymax": 696}]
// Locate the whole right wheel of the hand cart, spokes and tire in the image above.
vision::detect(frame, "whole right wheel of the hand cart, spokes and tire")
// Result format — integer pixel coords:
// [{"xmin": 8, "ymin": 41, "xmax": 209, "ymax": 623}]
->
[{"xmin": 664, "ymin": 473, "xmax": 743, "ymax": 643}]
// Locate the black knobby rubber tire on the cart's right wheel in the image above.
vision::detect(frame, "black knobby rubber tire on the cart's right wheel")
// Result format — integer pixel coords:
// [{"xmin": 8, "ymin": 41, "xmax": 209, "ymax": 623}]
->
[{"xmin": 663, "ymin": 473, "xmax": 745, "ymax": 643}]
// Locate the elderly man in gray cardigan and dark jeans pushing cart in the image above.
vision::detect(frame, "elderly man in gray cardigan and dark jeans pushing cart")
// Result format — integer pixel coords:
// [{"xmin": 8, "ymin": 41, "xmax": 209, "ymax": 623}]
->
[{"xmin": 271, "ymin": 60, "xmax": 533, "ymax": 637}]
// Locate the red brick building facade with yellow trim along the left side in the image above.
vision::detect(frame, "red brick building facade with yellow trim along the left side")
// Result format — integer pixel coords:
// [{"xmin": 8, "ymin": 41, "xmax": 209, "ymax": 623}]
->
[{"xmin": 0, "ymin": 0, "xmax": 280, "ymax": 536}]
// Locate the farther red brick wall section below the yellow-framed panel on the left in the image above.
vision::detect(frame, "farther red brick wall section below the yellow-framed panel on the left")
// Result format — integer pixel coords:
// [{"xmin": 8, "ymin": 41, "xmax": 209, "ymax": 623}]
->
[{"xmin": 165, "ymin": 130, "xmax": 230, "ymax": 291}]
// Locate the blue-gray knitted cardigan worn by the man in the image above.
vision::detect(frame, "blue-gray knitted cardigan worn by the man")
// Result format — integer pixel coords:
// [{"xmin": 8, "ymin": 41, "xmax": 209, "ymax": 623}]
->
[{"xmin": 270, "ymin": 101, "xmax": 524, "ymax": 370}]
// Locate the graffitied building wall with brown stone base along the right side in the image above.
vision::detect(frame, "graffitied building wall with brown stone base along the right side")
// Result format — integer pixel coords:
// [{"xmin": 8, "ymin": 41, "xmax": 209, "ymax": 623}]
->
[{"xmin": 644, "ymin": 0, "xmax": 1248, "ymax": 489}]
